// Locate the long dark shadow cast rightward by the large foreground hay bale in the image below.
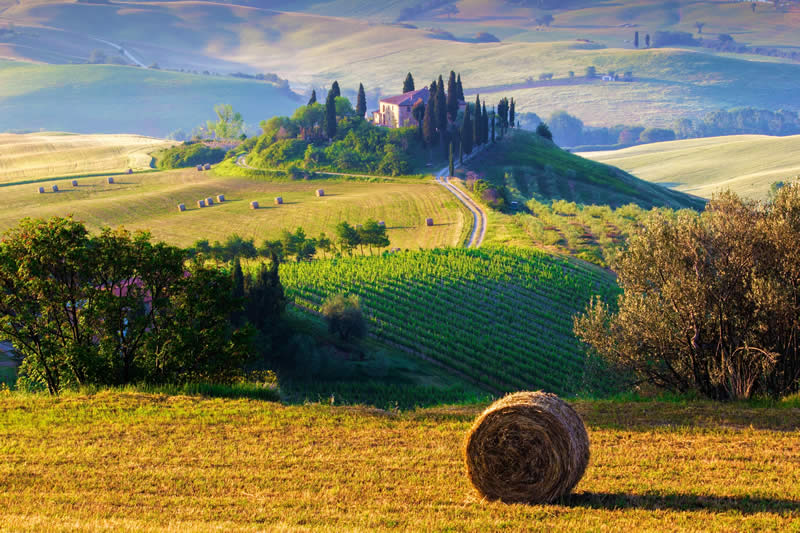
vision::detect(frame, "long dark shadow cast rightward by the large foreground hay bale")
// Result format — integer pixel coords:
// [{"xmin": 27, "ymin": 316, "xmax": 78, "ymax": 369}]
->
[{"xmin": 561, "ymin": 492, "xmax": 800, "ymax": 514}]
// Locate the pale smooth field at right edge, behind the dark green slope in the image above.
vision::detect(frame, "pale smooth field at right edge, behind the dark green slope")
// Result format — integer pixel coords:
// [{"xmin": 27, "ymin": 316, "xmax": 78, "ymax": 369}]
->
[{"xmin": 581, "ymin": 135, "xmax": 800, "ymax": 200}]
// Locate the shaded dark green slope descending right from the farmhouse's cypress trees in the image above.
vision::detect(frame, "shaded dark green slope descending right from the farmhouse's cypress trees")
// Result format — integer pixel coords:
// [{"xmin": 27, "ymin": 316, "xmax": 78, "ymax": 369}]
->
[{"xmin": 465, "ymin": 131, "xmax": 704, "ymax": 209}]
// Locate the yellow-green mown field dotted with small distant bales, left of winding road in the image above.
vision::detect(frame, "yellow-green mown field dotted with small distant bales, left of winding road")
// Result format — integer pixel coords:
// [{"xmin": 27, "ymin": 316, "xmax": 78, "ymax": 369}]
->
[{"xmin": 0, "ymin": 169, "xmax": 471, "ymax": 249}]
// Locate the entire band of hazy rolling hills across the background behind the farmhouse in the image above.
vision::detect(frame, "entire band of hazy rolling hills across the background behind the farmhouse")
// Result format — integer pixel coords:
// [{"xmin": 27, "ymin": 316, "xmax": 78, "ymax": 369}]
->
[{"xmin": 0, "ymin": 0, "xmax": 800, "ymax": 135}]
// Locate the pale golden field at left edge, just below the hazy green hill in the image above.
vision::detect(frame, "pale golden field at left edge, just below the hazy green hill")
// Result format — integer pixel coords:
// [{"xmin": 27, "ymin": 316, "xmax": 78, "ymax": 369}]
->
[{"xmin": 0, "ymin": 133, "xmax": 172, "ymax": 184}]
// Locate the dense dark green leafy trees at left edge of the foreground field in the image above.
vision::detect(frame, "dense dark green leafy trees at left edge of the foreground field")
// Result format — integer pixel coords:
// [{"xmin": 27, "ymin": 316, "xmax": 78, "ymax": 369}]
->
[{"xmin": 0, "ymin": 217, "xmax": 249, "ymax": 394}]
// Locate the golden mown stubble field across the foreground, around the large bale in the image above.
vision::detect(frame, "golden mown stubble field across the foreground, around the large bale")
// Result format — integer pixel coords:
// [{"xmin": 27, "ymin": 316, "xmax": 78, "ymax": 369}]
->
[{"xmin": 0, "ymin": 392, "xmax": 800, "ymax": 531}]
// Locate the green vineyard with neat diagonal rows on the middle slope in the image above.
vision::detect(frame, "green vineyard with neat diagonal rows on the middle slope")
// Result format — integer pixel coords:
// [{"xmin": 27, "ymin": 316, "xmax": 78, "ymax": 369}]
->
[{"xmin": 281, "ymin": 248, "xmax": 617, "ymax": 394}]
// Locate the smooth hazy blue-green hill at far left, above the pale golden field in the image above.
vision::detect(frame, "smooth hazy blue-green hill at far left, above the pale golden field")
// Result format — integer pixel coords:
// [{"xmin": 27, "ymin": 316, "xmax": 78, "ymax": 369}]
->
[{"xmin": 0, "ymin": 60, "xmax": 298, "ymax": 137}]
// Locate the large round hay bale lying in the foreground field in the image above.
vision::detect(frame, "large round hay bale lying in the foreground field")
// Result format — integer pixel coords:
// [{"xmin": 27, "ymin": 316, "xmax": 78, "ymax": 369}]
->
[{"xmin": 464, "ymin": 392, "xmax": 589, "ymax": 504}]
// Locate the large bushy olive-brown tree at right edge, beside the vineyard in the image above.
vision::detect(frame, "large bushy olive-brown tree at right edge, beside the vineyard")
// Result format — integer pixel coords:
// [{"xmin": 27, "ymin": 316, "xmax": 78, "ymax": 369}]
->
[{"xmin": 575, "ymin": 184, "xmax": 800, "ymax": 399}]
